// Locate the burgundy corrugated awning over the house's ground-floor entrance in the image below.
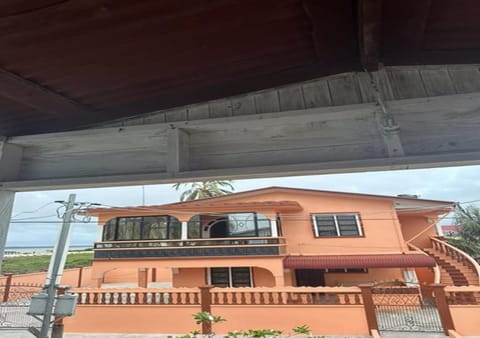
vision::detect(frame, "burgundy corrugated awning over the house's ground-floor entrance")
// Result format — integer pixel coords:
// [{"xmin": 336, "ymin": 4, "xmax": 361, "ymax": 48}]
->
[{"xmin": 283, "ymin": 254, "xmax": 435, "ymax": 269}]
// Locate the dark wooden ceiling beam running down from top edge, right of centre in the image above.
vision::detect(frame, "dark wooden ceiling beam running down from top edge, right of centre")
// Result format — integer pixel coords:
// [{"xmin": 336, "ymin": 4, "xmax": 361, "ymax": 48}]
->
[{"xmin": 357, "ymin": 0, "xmax": 383, "ymax": 71}]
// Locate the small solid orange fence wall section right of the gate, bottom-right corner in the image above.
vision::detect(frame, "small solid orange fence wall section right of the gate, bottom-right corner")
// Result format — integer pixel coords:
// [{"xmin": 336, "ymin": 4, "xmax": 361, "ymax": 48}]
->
[{"xmin": 450, "ymin": 305, "xmax": 480, "ymax": 336}]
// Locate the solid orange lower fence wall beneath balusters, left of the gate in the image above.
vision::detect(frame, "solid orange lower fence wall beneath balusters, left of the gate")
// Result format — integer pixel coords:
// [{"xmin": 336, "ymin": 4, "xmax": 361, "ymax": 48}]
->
[{"xmin": 64, "ymin": 305, "xmax": 368, "ymax": 335}]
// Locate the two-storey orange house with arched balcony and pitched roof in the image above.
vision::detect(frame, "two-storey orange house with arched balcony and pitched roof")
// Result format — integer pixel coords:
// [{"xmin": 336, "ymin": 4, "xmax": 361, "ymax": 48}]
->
[{"xmin": 90, "ymin": 187, "xmax": 462, "ymax": 288}]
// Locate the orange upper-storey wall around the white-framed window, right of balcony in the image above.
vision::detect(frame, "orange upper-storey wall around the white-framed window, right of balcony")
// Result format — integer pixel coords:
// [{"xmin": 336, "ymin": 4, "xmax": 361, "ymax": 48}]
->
[{"xmin": 202, "ymin": 192, "xmax": 407, "ymax": 255}]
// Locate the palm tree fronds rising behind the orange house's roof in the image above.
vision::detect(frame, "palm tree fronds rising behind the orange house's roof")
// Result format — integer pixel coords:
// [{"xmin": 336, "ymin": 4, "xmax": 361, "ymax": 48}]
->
[{"xmin": 173, "ymin": 180, "xmax": 235, "ymax": 202}]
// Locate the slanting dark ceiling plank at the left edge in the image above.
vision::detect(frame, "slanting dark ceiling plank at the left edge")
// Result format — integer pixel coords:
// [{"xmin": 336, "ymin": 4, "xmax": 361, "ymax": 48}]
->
[{"xmin": 0, "ymin": 69, "xmax": 90, "ymax": 116}]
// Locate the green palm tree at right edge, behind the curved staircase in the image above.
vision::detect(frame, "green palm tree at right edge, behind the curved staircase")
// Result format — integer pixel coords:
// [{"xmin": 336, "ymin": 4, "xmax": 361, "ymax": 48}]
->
[{"xmin": 447, "ymin": 206, "xmax": 480, "ymax": 258}]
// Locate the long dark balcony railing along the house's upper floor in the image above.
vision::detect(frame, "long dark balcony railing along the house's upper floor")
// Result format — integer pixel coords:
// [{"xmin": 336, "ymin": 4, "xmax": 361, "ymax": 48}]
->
[{"xmin": 94, "ymin": 237, "xmax": 285, "ymax": 259}]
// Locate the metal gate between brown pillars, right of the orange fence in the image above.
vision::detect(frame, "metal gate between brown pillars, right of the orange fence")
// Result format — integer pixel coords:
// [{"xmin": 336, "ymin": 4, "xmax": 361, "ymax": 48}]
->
[{"xmin": 372, "ymin": 285, "xmax": 443, "ymax": 332}]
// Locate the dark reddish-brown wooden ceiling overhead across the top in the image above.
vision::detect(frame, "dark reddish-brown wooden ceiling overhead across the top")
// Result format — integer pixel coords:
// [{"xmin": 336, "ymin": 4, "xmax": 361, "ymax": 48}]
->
[{"xmin": 0, "ymin": 0, "xmax": 480, "ymax": 136}]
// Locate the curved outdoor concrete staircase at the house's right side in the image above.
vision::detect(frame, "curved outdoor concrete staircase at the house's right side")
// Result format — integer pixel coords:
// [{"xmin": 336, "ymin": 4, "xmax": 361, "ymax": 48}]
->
[{"xmin": 424, "ymin": 248, "xmax": 479, "ymax": 286}]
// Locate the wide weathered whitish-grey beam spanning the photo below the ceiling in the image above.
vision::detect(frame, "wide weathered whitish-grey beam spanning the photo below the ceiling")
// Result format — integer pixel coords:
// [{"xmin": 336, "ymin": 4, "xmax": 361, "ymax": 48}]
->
[{"xmin": 0, "ymin": 93, "xmax": 480, "ymax": 191}]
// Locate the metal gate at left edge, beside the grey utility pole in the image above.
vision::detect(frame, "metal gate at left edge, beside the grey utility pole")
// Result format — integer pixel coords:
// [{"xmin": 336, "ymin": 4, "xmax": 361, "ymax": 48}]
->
[{"xmin": 0, "ymin": 284, "xmax": 42, "ymax": 330}]
